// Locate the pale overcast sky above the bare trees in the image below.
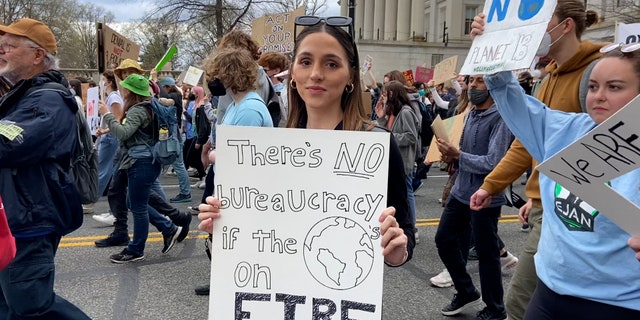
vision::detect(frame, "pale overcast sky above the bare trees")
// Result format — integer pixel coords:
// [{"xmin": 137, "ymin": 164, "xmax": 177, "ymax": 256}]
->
[{"xmin": 78, "ymin": 0, "xmax": 340, "ymax": 22}]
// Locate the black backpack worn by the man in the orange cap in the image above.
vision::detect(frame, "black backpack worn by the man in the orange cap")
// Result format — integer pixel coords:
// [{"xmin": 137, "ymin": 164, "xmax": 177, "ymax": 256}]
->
[{"xmin": 25, "ymin": 82, "xmax": 100, "ymax": 204}]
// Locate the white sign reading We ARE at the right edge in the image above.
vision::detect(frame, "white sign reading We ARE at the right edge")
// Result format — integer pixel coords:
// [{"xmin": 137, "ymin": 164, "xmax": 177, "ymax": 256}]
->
[{"xmin": 538, "ymin": 95, "xmax": 640, "ymax": 235}]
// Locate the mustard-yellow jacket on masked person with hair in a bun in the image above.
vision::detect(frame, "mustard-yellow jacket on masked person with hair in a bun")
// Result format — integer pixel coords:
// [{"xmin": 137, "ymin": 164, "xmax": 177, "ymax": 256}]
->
[{"xmin": 480, "ymin": 41, "xmax": 606, "ymax": 208}]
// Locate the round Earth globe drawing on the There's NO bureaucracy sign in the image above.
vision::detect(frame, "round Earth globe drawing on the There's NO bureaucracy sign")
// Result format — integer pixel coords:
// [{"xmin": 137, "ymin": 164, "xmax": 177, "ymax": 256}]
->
[{"xmin": 303, "ymin": 217, "xmax": 374, "ymax": 290}]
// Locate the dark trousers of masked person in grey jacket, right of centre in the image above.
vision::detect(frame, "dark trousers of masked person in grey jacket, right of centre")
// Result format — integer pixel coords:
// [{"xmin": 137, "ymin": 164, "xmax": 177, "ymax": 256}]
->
[{"xmin": 436, "ymin": 197, "xmax": 504, "ymax": 313}]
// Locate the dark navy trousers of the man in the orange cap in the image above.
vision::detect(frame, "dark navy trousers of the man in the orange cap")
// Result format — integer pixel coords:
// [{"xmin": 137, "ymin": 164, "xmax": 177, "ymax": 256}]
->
[{"xmin": 0, "ymin": 233, "xmax": 91, "ymax": 320}]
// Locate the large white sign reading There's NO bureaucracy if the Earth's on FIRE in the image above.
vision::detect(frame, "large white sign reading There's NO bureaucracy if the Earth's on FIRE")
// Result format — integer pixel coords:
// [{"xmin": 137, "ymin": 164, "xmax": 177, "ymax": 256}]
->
[{"xmin": 209, "ymin": 125, "xmax": 389, "ymax": 320}]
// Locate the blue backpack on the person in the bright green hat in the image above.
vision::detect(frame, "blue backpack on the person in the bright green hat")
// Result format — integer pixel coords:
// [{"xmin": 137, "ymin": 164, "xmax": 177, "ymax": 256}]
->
[{"xmin": 140, "ymin": 98, "xmax": 180, "ymax": 165}]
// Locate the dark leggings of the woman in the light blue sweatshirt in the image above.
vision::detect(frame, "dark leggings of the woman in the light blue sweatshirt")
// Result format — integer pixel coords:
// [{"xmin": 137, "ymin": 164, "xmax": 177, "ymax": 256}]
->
[{"xmin": 524, "ymin": 279, "xmax": 640, "ymax": 320}]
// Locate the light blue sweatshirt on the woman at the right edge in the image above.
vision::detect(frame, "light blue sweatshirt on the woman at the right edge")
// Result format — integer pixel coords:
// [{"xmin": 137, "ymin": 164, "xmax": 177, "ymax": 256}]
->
[{"xmin": 485, "ymin": 72, "xmax": 640, "ymax": 310}]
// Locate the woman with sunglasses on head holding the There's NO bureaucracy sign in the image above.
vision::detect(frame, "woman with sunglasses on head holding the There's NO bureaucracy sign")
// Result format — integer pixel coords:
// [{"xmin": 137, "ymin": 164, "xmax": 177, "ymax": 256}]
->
[{"xmin": 198, "ymin": 16, "xmax": 415, "ymax": 266}]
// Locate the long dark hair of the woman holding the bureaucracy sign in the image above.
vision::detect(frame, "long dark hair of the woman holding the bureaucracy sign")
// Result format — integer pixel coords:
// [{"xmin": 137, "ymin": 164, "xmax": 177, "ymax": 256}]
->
[{"xmin": 287, "ymin": 22, "xmax": 372, "ymax": 131}]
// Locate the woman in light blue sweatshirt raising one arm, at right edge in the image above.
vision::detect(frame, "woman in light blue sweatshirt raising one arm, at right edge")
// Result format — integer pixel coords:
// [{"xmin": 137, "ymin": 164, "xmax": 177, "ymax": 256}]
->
[{"xmin": 480, "ymin": 44, "xmax": 640, "ymax": 319}]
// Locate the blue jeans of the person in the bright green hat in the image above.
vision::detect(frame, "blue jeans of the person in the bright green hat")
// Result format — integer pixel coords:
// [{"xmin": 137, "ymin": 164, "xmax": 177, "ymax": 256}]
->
[{"xmin": 126, "ymin": 158, "xmax": 164, "ymax": 254}]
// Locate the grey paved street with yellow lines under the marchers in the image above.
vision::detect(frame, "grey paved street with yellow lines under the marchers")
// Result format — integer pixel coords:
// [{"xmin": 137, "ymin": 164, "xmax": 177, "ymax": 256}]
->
[{"xmin": 56, "ymin": 168, "xmax": 526, "ymax": 320}]
